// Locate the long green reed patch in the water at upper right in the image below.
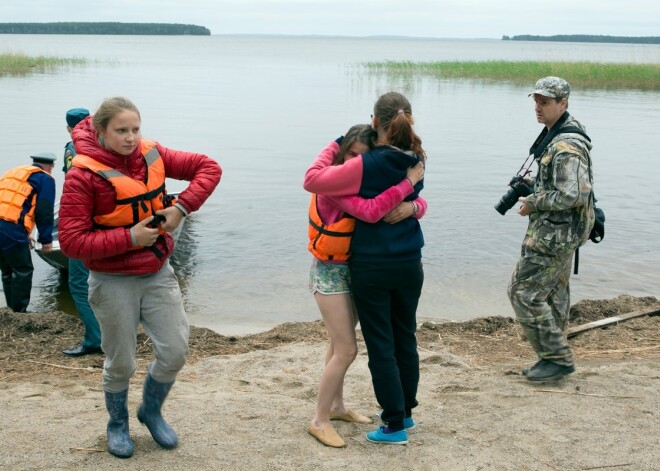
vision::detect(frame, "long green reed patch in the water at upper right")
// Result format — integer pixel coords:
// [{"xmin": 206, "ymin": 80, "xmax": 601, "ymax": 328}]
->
[{"xmin": 363, "ymin": 61, "xmax": 660, "ymax": 90}]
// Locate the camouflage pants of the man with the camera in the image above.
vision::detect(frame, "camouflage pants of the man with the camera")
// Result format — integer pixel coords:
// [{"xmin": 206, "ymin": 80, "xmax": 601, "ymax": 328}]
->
[{"xmin": 508, "ymin": 246, "xmax": 573, "ymax": 366}]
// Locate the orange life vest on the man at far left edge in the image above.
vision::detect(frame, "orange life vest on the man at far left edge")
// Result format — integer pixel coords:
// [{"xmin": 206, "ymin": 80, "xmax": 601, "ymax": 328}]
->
[{"xmin": 0, "ymin": 165, "xmax": 43, "ymax": 234}]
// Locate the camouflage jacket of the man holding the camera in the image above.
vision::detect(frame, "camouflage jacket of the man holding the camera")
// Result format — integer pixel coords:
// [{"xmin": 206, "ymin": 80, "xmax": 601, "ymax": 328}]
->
[{"xmin": 523, "ymin": 116, "xmax": 594, "ymax": 255}]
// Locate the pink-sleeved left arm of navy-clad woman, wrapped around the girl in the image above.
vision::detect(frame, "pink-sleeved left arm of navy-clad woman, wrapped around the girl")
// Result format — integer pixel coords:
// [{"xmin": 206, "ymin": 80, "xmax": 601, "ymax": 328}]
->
[{"xmin": 303, "ymin": 141, "xmax": 362, "ymax": 196}]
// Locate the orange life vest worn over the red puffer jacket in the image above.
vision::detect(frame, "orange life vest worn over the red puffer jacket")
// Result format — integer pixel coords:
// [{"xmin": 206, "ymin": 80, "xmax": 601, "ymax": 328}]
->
[{"xmin": 73, "ymin": 139, "xmax": 173, "ymax": 229}]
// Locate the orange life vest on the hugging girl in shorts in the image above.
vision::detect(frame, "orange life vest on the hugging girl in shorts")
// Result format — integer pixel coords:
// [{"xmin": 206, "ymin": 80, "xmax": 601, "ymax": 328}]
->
[{"xmin": 307, "ymin": 195, "xmax": 355, "ymax": 261}]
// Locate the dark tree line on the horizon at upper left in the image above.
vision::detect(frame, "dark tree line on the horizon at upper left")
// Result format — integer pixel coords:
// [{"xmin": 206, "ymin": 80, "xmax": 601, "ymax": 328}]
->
[{"xmin": 0, "ymin": 22, "xmax": 211, "ymax": 36}]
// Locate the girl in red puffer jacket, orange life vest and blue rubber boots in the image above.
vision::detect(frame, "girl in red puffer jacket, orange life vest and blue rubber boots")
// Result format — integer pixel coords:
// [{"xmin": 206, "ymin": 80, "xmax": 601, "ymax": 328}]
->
[{"xmin": 59, "ymin": 97, "xmax": 222, "ymax": 458}]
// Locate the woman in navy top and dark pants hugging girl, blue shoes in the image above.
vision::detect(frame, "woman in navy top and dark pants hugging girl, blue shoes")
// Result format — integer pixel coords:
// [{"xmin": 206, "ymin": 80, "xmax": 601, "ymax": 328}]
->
[{"xmin": 304, "ymin": 92, "xmax": 426, "ymax": 445}]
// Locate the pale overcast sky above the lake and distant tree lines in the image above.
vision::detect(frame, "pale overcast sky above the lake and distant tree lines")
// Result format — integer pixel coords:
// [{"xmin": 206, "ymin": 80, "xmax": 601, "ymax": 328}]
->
[{"xmin": 0, "ymin": 0, "xmax": 660, "ymax": 39}]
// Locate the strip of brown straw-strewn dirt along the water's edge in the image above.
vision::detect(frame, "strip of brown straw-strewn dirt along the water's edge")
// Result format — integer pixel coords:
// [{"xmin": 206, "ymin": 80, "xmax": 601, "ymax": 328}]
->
[{"xmin": 0, "ymin": 295, "xmax": 660, "ymax": 381}]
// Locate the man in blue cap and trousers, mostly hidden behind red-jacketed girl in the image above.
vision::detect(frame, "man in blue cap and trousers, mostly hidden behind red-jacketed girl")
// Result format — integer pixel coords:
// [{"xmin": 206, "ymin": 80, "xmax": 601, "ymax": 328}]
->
[{"xmin": 62, "ymin": 108, "xmax": 102, "ymax": 357}]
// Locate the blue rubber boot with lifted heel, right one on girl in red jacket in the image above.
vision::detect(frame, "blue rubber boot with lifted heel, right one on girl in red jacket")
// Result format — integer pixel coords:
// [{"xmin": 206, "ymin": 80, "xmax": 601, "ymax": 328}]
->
[{"xmin": 138, "ymin": 374, "xmax": 179, "ymax": 449}]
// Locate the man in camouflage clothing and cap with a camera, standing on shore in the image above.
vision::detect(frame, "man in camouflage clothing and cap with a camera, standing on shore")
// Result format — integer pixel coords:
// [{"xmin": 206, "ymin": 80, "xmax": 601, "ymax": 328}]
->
[{"xmin": 508, "ymin": 77, "xmax": 594, "ymax": 381}]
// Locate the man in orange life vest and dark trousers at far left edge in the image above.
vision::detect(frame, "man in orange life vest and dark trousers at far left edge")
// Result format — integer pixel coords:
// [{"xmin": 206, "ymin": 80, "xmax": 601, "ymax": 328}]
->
[{"xmin": 0, "ymin": 152, "xmax": 56, "ymax": 312}]
